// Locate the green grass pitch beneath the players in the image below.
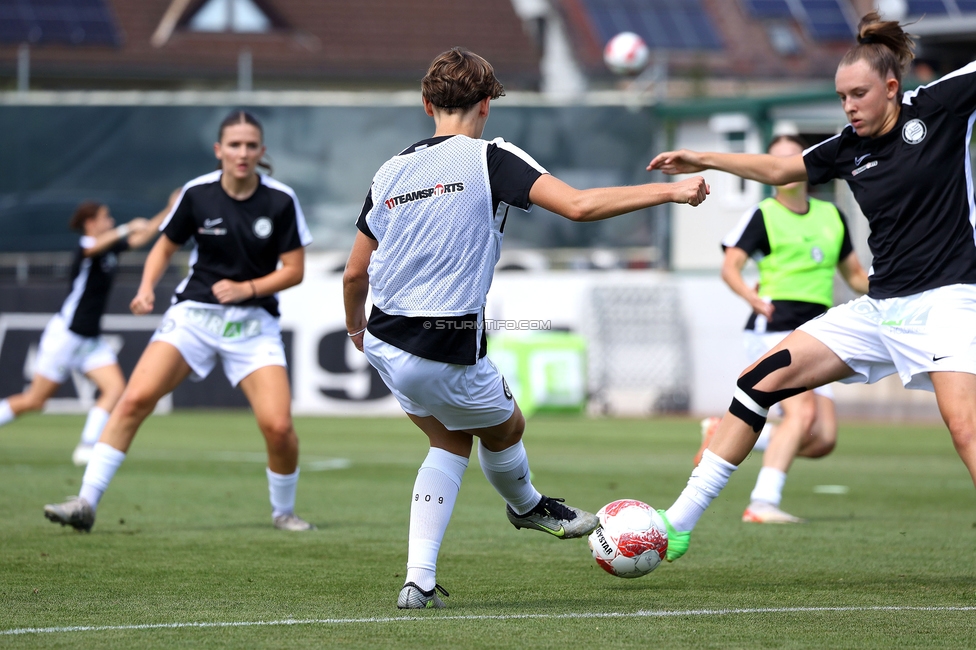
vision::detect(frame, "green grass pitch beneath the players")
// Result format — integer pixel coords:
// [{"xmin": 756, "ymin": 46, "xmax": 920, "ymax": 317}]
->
[{"xmin": 0, "ymin": 412, "xmax": 976, "ymax": 648}]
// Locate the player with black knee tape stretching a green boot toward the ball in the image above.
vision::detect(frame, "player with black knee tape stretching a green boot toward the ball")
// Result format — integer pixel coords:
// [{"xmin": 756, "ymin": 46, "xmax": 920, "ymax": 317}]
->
[{"xmin": 648, "ymin": 12, "xmax": 976, "ymax": 560}]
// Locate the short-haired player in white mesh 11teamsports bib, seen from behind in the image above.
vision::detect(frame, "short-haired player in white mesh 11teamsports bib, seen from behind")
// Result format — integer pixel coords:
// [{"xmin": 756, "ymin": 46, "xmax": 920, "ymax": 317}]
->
[{"xmin": 344, "ymin": 48, "xmax": 708, "ymax": 609}]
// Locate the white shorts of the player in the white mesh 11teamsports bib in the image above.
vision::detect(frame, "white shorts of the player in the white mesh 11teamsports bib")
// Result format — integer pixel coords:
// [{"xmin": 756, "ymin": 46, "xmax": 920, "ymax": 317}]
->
[{"xmin": 363, "ymin": 331, "xmax": 515, "ymax": 431}]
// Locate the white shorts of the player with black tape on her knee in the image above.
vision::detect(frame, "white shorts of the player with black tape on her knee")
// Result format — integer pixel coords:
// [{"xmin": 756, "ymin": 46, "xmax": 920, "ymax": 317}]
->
[{"xmin": 798, "ymin": 284, "xmax": 976, "ymax": 391}]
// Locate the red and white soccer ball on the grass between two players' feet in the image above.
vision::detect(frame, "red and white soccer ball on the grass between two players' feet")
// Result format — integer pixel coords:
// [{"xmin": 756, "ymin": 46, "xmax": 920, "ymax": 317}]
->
[{"xmin": 589, "ymin": 499, "xmax": 668, "ymax": 578}]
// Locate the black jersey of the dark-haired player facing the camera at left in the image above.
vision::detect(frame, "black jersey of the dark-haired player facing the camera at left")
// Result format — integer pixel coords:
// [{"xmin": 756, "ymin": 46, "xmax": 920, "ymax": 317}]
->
[{"xmin": 159, "ymin": 170, "xmax": 312, "ymax": 317}]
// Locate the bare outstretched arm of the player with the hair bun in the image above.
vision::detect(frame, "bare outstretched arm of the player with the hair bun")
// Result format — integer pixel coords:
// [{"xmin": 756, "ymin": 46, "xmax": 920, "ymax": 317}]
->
[{"xmin": 647, "ymin": 149, "xmax": 807, "ymax": 185}]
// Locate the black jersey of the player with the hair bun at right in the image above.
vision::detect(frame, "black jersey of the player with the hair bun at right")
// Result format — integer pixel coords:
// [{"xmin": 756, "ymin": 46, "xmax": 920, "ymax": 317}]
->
[{"xmin": 803, "ymin": 62, "xmax": 976, "ymax": 298}]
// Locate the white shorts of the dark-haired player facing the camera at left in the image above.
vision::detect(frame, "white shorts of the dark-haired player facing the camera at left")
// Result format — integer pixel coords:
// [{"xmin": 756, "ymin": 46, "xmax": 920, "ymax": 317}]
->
[{"xmin": 150, "ymin": 300, "xmax": 288, "ymax": 386}]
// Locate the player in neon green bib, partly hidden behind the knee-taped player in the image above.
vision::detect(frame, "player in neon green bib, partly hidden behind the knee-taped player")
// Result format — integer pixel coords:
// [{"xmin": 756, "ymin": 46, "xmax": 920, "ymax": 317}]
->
[{"xmin": 695, "ymin": 135, "xmax": 868, "ymax": 524}]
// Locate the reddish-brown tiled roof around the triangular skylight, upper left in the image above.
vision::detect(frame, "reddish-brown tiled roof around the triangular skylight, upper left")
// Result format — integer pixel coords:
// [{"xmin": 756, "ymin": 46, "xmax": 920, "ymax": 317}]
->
[{"xmin": 0, "ymin": 0, "xmax": 539, "ymax": 88}]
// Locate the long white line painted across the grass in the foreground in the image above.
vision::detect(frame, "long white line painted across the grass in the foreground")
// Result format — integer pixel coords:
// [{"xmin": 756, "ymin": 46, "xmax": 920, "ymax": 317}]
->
[{"xmin": 0, "ymin": 606, "xmax": 976, "ymax": 636}]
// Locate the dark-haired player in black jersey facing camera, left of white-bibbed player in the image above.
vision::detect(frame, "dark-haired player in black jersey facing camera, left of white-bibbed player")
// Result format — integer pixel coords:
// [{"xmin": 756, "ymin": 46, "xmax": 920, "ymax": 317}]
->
[{"xmin": 44, "ymin": 111, "xmax": 313, "ymax": 531}]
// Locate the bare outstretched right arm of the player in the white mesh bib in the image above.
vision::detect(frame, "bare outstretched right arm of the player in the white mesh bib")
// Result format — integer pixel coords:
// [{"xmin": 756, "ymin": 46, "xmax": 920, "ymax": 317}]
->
[{"xmin": 529, "ymin": 174, "xmax": 709, "ymax": 221}]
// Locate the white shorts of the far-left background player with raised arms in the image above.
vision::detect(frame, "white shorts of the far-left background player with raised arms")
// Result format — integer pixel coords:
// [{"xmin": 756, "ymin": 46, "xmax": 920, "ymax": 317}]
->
[{"xmin": 35, "ymin": 314, "xmax": 119, "ymax": 384}]
